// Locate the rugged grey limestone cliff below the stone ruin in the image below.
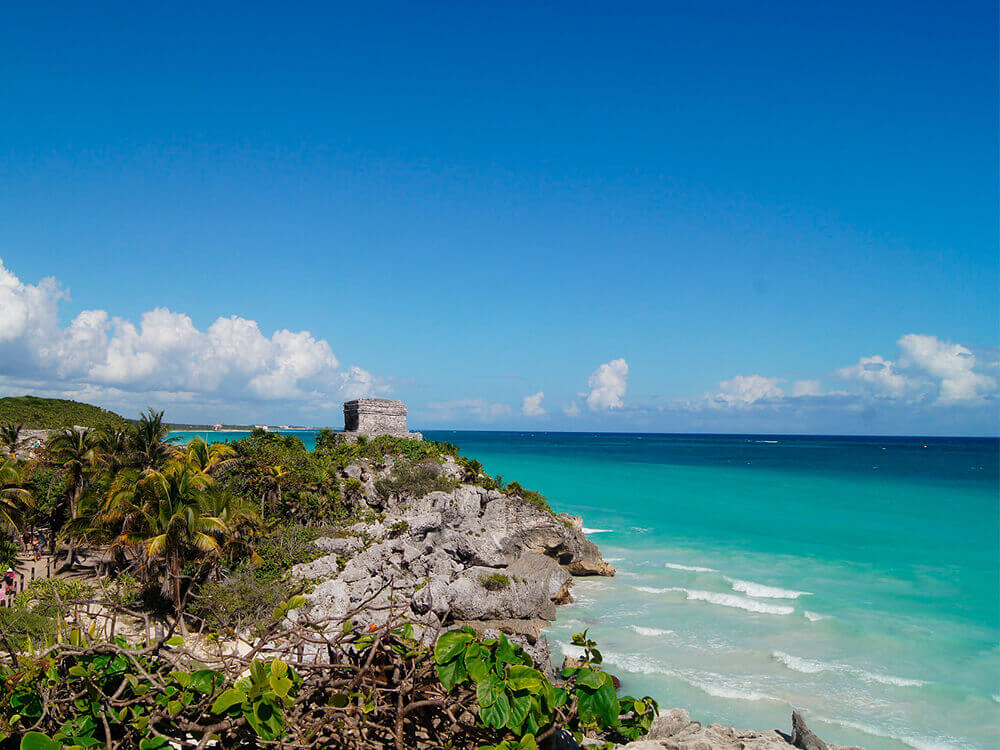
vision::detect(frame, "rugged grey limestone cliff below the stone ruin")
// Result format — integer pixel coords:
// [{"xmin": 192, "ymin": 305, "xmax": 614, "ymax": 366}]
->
[{"xmin": 293, "ymin": 458, "xmax": 615, "ymax": 648}]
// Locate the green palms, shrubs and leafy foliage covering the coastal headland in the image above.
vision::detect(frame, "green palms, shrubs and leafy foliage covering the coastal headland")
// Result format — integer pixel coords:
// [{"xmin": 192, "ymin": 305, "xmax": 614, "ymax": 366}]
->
[{"xmin": 0, "ymin": 402, "xmax": 657, "ymax": 750}]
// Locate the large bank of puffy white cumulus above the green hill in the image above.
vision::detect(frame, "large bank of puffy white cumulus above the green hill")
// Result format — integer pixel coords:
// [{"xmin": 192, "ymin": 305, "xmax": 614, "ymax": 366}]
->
[{"xmin": 0, "ymin": 260, "xmax": 389, "ymax": 412}]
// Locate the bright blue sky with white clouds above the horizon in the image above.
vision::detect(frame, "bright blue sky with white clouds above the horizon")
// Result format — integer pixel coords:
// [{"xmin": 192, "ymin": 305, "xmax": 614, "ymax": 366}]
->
[{"xmin": 0, "ymin": 1, "xmax": 1000, "ymax": 435}]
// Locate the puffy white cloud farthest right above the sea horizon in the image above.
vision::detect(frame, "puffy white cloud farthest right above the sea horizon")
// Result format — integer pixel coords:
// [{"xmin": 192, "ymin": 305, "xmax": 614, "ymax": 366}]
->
[{"xmin": 898, "ymin": 333, "xmax": 997, "ymax": 404}]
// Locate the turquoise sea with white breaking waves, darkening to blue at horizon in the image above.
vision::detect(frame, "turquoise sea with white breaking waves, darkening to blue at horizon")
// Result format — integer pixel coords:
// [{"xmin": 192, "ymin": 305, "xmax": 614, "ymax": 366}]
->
[{"xmin": 174, "ymin": 432, "xmax": 1000, "ymax": 750}]
